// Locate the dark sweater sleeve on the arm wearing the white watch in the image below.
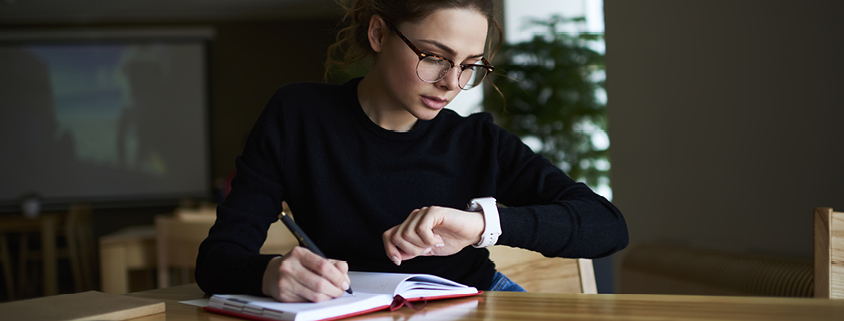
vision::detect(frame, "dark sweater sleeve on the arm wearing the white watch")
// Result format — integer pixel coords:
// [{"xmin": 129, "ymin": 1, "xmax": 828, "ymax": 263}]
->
[{"xmin": 491, "ymin": 125, "xmax": 628, "ymax": 258}]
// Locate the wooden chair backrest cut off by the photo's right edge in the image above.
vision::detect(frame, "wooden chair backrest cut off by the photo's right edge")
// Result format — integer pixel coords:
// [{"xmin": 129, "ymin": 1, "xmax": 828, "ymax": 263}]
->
[{"xmin": 814, "ymin": 207, "xmax": 844, "ymax": 299}]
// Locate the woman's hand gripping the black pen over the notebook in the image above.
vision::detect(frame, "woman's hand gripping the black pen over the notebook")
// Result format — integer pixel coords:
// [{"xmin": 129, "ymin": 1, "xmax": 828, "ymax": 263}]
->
[{"xmin": 261, "ymin": 246, "xmax": 350, "ymax": 302}]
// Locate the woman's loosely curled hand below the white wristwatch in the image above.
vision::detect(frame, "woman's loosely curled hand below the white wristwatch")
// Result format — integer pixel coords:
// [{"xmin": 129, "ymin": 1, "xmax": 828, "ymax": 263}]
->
[{"xmin": 382, "ymin": 206, "xmax": 484, "ymax": 265}]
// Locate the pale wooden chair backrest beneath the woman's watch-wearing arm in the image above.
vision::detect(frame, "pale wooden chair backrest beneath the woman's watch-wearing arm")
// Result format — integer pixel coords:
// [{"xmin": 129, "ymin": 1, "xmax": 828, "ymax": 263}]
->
[{"xmin": 489, "ymin": 245, "xmax": 598, "ymax": 294}]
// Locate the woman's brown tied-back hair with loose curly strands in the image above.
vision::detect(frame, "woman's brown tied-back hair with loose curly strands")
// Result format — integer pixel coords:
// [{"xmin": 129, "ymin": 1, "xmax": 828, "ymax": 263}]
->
[{"xmin": 325, "ymin": 0, "xmax": 504, "ymax": 79}]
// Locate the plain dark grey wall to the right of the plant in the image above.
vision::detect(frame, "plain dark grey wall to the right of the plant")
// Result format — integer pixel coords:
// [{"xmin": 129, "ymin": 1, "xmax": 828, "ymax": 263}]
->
[{"xmin": 604, "ymin": 0, "xmax": 844, "ymax": 286}]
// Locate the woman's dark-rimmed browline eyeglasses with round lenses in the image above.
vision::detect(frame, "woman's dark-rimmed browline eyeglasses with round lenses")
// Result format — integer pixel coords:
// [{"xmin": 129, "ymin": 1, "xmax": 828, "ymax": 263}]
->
[{"xmin": 387, "ymin": 23, "xmax": 495, "ymax": 90}]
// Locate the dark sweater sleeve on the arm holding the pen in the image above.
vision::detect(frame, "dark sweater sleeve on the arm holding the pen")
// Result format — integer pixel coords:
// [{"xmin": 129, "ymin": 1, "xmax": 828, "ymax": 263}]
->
[{"xmin": 195, "ymin": 93, "xmax": 284, "ymax": 295}]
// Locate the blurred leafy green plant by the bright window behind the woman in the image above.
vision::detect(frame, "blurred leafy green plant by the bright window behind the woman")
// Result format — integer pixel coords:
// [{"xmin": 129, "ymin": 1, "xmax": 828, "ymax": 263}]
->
[{"xmin": 484, "ymin": 16, "xmax": 609, "ymax": 188}]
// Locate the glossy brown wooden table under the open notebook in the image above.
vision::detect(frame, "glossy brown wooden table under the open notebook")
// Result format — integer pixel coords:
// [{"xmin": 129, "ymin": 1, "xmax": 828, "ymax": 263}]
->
[{"xmin": 127, "ymin": 284, "xmax": 844, "ymax": 321}]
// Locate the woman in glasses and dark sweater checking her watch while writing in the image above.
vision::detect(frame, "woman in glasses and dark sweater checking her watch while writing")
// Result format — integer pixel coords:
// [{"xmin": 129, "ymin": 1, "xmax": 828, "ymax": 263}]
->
[{"xmin": 196, "ymin": 0, "xmax": 627, "ymax": 301}]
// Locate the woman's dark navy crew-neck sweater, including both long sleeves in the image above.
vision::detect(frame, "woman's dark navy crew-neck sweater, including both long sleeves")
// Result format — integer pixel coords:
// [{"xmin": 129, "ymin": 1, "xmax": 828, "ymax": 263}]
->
[{"xmin": 196, "ymin": 79, "xmax": 628, "ymax": 294}]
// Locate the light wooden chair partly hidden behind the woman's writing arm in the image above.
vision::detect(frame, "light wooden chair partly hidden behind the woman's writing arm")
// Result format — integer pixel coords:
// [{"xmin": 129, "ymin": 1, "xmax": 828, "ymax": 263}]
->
[{"xmin": 155, "ymin": 208, "xmax": 299, "ymax": 288}]
